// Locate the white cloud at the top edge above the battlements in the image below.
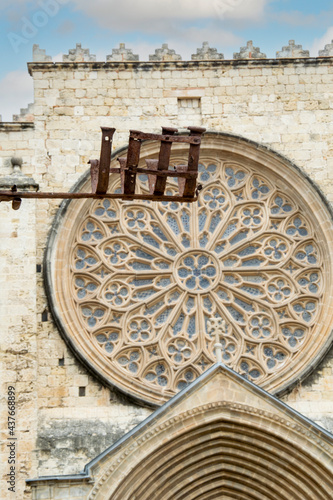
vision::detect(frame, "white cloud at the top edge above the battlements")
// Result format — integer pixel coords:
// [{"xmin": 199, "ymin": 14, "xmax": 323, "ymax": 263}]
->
[{"xmin": 73, "ymin": 0, "xmax": 269, "ymax": 33}]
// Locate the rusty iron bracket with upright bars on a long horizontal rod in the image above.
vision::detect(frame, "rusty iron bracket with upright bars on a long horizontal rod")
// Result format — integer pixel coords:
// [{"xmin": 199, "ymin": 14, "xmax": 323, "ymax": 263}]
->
[{"xmin": 0, "ymin": 127, "xmax": 205, "ymax": 210}]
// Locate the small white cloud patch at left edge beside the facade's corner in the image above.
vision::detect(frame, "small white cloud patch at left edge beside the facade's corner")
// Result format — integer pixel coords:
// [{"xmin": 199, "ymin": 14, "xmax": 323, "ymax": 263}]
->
[{"xmin": 0, "ymin": 70, "xmax": 33, "ymax": 121}]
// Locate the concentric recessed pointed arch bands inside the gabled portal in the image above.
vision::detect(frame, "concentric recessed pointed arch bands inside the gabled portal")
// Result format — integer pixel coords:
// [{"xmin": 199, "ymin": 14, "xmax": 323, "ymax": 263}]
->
[{"xmin": 109, "ymin": 420, "xmax": 333, "ymax": 500}]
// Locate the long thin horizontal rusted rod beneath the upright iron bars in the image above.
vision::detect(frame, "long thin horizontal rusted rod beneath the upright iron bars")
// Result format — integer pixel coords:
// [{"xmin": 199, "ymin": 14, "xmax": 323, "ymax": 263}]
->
[{"xmin": 0, "ymin": 191, "xmax": 198, "ymax": 202}]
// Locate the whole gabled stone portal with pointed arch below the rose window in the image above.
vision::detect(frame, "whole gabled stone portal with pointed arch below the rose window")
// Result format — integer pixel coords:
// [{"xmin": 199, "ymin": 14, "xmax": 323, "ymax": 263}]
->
[{"xmin": 85, "ymin": 364, "xmax": 333, "ymax": 500}]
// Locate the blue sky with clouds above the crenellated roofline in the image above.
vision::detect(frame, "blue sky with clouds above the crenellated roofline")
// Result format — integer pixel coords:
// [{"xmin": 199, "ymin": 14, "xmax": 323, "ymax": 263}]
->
[{"xmin": 0, "ymin": 0, "xmax": 333, "ymax": 121}]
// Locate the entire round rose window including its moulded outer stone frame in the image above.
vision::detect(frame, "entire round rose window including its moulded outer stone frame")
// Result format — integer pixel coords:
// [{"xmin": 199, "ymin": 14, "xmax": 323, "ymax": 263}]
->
[{"xmin": 45, "ymin": 133, "xmax": 333, "ymax": 406}]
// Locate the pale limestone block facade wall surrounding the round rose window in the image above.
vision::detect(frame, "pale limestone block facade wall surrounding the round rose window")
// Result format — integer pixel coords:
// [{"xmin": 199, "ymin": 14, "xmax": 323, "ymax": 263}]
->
[{"xmin": 0, "ymin": 47, "xmax": 333, "ymax": 500}]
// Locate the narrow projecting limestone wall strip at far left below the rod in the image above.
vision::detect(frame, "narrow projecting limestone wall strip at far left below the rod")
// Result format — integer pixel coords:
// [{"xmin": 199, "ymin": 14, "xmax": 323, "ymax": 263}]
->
[{"xmin": 0, "ymin": 200, "xmax": 39, "ymax": 499}]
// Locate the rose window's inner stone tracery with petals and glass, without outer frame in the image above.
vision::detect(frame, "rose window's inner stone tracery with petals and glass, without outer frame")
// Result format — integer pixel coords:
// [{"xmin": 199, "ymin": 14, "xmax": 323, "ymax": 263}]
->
[{"xmin": 71, "ymin": 156, "xmax": 324, "ymax": 397}]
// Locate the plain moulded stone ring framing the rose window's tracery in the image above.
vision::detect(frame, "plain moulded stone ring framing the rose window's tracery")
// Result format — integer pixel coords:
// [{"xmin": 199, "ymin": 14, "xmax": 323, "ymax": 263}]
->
[{"xmin": 44, "ymin": 132, "xmax": 333, "ymax": 407}]
